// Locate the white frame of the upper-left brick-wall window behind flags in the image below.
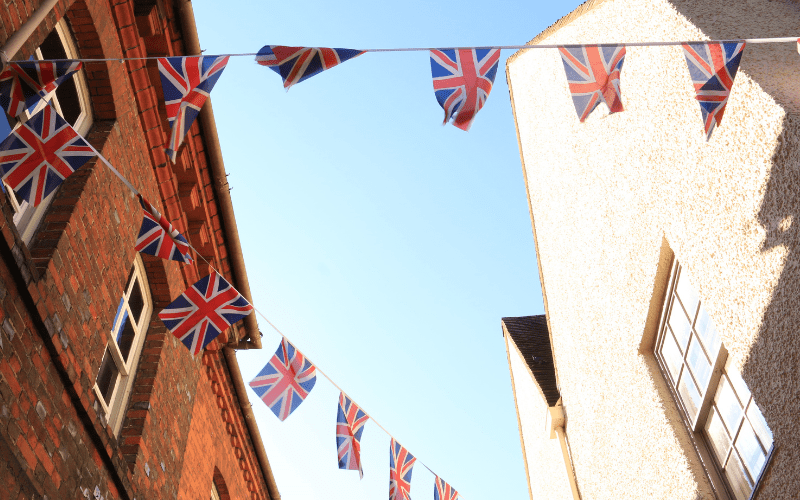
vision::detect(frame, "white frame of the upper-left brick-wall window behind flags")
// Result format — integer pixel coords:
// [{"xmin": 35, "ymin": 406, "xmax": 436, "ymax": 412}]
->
[{"xmin": 4, "ymin": 19, "xmax": 94, "ymax": 245}]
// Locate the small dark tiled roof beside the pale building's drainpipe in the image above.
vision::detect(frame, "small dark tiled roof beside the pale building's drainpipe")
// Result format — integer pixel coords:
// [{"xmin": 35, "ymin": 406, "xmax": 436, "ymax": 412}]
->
[{"xmin": 503, "ymin": 314, "xmax": 561, "ymax": 406}]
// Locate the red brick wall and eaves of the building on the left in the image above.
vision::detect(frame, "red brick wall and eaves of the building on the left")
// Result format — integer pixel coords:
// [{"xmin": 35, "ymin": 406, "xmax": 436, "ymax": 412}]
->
[{"xmin": 0, "ymin": 0, "xmax": 279, "ymax": 500}]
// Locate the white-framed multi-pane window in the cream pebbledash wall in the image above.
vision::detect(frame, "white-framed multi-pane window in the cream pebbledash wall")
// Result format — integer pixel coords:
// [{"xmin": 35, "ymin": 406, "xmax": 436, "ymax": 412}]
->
[{"xmin": 656, "ymin": 262, "xmax": 773, "ymax": 500}]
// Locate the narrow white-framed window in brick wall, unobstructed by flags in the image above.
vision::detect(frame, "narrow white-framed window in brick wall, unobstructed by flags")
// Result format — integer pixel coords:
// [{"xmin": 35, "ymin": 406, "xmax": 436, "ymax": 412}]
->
[{"xmin": 94, "ymin": 256, "xmax": 153, "ymax": 434}]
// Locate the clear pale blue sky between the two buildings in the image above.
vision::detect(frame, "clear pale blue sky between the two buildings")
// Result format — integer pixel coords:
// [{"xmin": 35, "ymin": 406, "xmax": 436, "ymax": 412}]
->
[{"xmin": 192, "ymin": 0, "xmax": 580, "ymax": 500}]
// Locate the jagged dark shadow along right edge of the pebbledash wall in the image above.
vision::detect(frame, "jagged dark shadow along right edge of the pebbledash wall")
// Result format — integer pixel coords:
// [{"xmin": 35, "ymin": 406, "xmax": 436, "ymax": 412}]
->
[{"xmin": 671, "ymin": 0, "xmax": 800, "ymax": 497}]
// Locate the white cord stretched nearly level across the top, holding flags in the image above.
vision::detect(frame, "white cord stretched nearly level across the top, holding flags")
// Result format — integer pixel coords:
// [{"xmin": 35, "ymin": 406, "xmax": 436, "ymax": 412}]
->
[{"xmin": 10, "ymin": 37, "xmax": 798, "ymax": 63}]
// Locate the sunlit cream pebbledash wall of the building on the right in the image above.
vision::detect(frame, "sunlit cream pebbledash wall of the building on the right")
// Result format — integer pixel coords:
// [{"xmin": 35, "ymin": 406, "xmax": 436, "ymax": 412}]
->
[{"xmin": 507, "ymin": 0, "xmax": 800, "ymax": 500}]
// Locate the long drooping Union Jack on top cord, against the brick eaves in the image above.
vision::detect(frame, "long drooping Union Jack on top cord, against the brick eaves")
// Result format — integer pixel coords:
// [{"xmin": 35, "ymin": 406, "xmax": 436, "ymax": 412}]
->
[{"xmin": 158, "ymin": 56, "xmax": 230, "ymax": 162}]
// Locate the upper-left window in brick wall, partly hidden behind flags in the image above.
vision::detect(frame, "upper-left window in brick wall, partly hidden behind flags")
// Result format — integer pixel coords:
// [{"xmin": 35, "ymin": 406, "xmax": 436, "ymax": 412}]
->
[{"xmin": 0, "ymin": 19, "xmax": 92, "ymax": 244}]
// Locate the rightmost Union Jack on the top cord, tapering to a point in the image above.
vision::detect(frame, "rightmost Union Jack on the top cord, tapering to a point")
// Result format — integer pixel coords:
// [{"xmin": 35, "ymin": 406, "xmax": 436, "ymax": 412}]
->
[{"xmin": 683, "ymin": 42, "xmax": 745, "ymax": 141}]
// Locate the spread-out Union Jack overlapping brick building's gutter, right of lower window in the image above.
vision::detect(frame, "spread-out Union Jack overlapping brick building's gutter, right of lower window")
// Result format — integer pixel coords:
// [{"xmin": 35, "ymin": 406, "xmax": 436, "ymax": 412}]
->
[{"xmin": 158, "ymin": 269, "xmax": 253, "ymax": 355}]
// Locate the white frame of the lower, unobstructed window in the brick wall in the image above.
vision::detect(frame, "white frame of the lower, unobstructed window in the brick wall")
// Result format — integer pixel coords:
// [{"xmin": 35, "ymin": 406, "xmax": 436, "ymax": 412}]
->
[{"xmin": 94, "ymin": 254, "xmax": 153, "ymax": 435}]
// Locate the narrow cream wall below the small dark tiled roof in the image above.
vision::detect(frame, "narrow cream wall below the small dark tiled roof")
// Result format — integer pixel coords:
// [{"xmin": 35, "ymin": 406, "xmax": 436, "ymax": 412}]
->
[{"xmin": 505, "ymin": 335, "xmax": 572, "ymax": 500}]
